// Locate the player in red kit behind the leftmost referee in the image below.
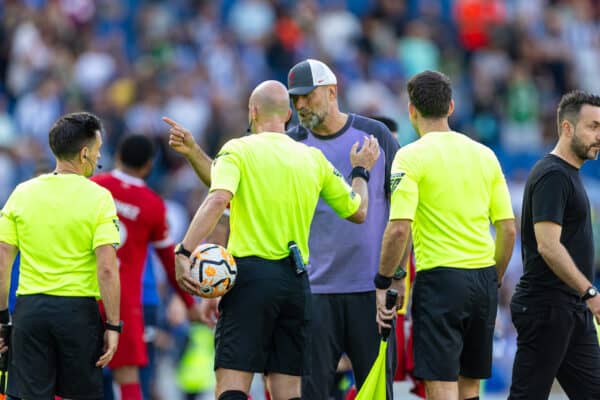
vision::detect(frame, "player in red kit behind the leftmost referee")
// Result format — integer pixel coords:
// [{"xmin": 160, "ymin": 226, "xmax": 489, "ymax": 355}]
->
[{"xmin": 92, "ymin": 135, "xmax": 199, "ymax": 400}]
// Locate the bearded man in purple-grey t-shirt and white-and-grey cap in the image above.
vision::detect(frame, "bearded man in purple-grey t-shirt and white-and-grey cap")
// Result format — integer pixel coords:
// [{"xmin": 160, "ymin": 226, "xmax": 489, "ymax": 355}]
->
[{"xmin": 288, "ymin": 59, "xmax": 406, "ymax": 400}]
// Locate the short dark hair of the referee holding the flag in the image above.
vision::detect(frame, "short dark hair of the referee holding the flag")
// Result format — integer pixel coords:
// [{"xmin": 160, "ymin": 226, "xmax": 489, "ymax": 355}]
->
[{"xmin": 407, "ymin": 71, "xmax": 452, "ymax": 118}]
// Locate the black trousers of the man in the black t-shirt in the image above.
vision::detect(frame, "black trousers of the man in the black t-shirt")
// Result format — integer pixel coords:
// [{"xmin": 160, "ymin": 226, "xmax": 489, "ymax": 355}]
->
[{"xmin": 509, "ymin": 299, "xmax": 600, "ymax": 400}]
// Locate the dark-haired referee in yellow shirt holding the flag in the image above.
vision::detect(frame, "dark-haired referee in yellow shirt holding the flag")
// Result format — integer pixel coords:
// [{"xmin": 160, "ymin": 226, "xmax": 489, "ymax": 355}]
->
[{"xmin": 375, "ymin": 71, "xmax": 515, "ymax": 400}]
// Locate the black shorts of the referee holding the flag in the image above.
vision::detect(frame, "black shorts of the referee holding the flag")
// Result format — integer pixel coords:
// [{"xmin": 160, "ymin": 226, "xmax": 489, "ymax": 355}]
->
[{"xmin": 412, "ymin": 267, "xmax": 498, "ymax": 381}]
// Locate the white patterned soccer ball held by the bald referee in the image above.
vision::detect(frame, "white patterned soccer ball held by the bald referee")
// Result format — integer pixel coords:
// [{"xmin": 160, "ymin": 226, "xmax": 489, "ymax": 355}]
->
[{"xmin": 190, "ymin": 243, "xmax": 237, "ymax": 298}]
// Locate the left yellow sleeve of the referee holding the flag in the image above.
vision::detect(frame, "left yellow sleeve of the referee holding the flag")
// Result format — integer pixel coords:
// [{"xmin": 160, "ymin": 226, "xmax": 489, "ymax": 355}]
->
[{"xmin": 390, "ymin": 147, "xmax": 419, "ymax": 221}]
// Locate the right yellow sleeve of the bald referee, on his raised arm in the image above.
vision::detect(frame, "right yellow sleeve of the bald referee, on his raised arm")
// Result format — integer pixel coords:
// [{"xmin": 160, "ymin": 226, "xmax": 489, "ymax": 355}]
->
[{"xmin": 318, "ymin": 149, "xmax": 361, "ymax": 219}]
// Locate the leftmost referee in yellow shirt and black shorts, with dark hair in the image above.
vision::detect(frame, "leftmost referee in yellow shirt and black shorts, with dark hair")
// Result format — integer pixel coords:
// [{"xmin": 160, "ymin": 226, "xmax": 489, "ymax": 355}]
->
[{"xmin": 0, "ymin": 112, "xmax": 121, "ymax": 400}]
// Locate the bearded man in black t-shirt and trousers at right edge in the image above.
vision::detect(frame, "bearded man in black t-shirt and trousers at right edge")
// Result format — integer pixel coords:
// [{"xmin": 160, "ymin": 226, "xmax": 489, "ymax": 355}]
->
[{"xmin": 509, "ymin": 91, "xmax": 600, "ymax": 400}]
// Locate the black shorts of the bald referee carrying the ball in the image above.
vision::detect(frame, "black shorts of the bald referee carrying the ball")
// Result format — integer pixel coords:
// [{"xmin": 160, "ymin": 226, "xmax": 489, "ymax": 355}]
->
[{"xmin": 215, "ymin": 257, "xmax": 311, "ymax": 376}]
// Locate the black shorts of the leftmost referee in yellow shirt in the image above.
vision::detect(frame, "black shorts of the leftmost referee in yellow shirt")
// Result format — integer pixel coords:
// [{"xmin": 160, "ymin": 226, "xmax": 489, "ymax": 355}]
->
[{"xmin": 7, "ymin": 295, "xmax": 104, "ymax": 400}]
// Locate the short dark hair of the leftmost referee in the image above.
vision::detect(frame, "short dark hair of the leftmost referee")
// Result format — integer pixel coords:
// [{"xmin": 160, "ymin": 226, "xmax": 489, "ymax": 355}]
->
[{"xmin": 48, "ymin": 111, "xmax": 102, "ymax": 160}]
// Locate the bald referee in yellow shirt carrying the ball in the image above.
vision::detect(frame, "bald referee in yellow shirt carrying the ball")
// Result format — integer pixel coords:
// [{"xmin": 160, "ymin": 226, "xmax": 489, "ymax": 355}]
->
[{"xmin": 176, "ymin": 81, "xmax": 379, "ymax": 400}]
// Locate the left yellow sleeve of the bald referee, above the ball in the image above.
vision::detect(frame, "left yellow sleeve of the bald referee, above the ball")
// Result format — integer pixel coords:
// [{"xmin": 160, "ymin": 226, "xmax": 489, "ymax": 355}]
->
[{"xmin": 210, "ymin": 141, "xmax": 241, "ymax": 194}]
